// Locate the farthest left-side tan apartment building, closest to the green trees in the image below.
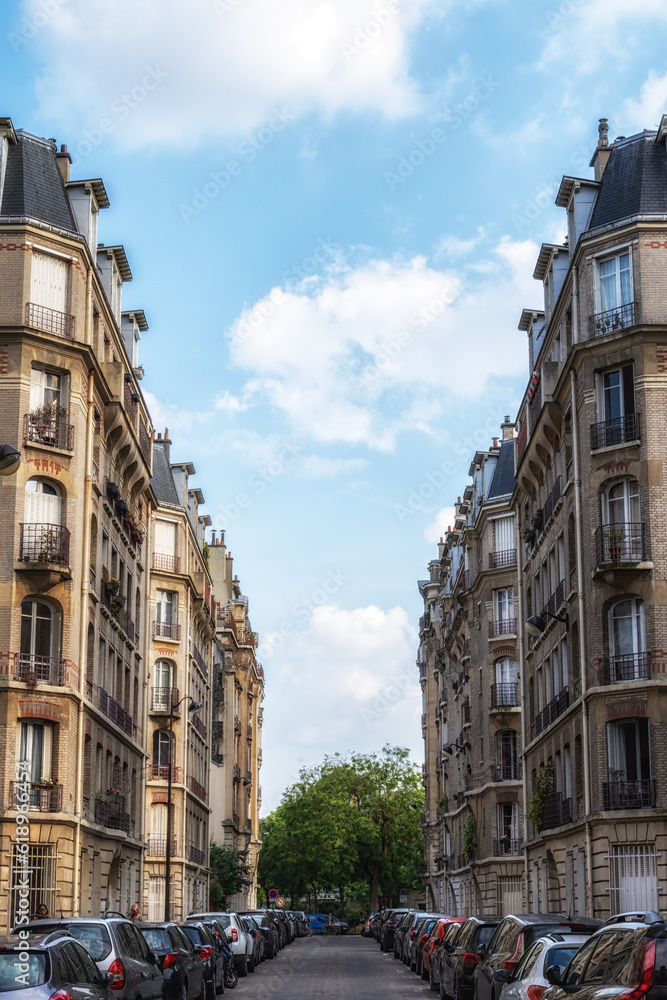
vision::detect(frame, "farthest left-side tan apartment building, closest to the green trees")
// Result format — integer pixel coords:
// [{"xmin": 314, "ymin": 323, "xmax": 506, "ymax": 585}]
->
[{"xmin": 209, "ymin": 533, "xmax": 264, "ymax": 909}]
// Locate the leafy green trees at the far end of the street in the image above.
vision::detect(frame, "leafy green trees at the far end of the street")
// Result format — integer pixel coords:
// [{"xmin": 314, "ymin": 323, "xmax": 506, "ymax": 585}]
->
[{"xmin": 259, "ymin": 746, "xmax": 424, "ymax": 907}]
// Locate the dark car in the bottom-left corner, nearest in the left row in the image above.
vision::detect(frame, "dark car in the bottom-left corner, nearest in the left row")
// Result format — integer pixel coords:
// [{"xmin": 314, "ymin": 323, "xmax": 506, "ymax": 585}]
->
[{"xmin": 0, "ymin": 929, "xmax": 112, "ymax": 1000}]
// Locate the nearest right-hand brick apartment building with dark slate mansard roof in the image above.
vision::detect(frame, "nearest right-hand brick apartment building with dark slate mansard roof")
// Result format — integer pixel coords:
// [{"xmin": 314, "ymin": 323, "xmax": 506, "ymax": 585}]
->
[{"xmin": 513, "ymin": 116, "xmax": 667, "ymax": 917}]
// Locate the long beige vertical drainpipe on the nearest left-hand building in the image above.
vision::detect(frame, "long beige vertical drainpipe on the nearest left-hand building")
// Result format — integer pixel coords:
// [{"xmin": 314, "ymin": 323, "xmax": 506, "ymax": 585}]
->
[{"xmin": 72, "ymin": 366, "xmax": 95, "ymax": 917}]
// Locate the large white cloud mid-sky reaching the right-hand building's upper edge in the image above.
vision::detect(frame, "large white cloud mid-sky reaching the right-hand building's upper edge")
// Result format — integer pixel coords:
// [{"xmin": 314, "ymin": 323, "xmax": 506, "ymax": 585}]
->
[{"xmin": 228, "ymin": 237, "xmax": 537, "ymax": 451}]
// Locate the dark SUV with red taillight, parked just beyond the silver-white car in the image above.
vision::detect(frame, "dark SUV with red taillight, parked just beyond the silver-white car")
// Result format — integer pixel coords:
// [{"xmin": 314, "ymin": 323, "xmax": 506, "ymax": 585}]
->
[{"xmin": 473, "ymin": 913, "xmax": 601, "ymax": 1000}]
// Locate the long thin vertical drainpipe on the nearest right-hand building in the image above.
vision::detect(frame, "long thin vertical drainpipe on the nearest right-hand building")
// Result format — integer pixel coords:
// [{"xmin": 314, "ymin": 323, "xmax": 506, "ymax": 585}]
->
[{"xmin": 570, "ymin": 370, "xmax": 594, "ymax": 917}]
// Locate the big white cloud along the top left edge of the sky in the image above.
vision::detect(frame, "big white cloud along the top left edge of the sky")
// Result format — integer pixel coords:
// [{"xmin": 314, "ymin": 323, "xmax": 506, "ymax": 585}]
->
[{"xmin": 26, "ymin": 0, "xmax": 439, "ymax": 149}]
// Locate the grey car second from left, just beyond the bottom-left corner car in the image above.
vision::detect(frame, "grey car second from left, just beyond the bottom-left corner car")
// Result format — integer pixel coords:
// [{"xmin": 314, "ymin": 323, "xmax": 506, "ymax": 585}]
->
[{"xmin": 14, "ymin": 917, "xmax": 163, "ymax": 1000}]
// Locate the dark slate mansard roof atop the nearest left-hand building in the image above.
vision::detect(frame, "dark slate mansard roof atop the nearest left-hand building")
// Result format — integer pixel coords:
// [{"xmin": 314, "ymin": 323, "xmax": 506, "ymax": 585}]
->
[{"xmin": 0, "ymin": 131, "xmax": 77, "ymax": 232}]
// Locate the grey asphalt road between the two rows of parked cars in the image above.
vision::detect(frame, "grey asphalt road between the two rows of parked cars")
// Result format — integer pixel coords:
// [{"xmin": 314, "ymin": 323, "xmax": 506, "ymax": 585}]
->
[{"xmin": 230, "ymin": 934, "xmax": 437, "ymax": 1000}]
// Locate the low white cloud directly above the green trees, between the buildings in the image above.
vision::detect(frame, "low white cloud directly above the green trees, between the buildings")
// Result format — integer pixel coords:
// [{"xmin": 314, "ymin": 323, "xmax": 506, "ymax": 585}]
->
[{"xmin": 258, "ymin": 604, "xmax": 421, "ymax": 812}]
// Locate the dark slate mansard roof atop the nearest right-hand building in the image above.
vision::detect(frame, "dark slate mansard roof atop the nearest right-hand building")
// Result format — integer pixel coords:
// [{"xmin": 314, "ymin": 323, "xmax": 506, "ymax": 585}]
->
[{"xmin": 590, "ymin": 132, "xmax": 667, "ymax": 229}]
